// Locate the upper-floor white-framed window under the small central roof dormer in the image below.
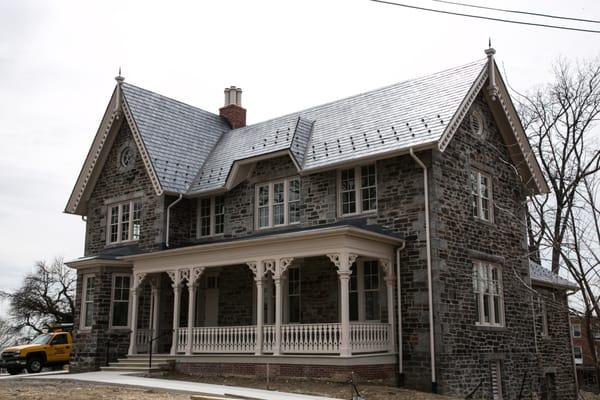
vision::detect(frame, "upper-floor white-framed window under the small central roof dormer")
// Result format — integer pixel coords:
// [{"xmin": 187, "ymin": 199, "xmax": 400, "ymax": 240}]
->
[{"xmin": 256, "ymin": 178, "xmax": 300, "ymax": 229}]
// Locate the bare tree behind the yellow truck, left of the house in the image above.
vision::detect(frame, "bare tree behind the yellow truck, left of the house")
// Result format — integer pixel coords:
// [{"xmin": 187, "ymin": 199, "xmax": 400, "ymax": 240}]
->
[{"xmin": 0, "ymin": 258, "xmax": 77, "ymax": 333}]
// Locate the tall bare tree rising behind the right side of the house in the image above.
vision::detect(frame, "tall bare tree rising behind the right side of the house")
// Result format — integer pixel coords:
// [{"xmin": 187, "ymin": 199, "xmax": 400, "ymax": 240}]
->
[{"xmin": 517, "ymin": 60, "xmax": 600, "ymax": 273}]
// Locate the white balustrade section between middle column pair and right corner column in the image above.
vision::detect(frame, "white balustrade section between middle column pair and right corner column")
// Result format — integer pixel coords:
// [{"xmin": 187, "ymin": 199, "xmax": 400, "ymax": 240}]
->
[{"xmin": 281, "ymin": 323, "xmax": 341, "ymax": 353}]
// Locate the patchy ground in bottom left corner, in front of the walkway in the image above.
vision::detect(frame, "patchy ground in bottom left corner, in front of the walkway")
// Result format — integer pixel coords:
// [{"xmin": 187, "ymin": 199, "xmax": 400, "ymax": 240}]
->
[{"xmin": 0, "ymin": 379, "xmax": 190, "ymax": 400}]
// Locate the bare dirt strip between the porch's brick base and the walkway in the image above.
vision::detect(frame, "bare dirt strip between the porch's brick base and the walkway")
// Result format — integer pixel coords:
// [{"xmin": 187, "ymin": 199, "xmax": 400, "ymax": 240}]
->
[{"xmin": 160, "ymin": 373, "xmax": 455, "ymax": 400}]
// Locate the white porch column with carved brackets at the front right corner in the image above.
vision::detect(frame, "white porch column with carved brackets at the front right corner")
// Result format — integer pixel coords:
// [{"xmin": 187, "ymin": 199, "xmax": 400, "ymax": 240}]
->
[{"xmin": 327, "ymin": 253, "xmax": 358, "ymax": 357}]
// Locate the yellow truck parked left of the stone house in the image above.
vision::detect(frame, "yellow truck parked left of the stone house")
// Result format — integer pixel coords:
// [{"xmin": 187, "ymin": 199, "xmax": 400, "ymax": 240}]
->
[{"xmin": 0, "ymin": 329, "xmax": 73, "ymax": 375}]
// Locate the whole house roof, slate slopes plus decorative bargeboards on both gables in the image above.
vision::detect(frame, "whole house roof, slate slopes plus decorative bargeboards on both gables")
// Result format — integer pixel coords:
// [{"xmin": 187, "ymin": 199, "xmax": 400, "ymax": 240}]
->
[{"xmin": 65, "ymin": 55, "xmax": 548, "ymax": 213}]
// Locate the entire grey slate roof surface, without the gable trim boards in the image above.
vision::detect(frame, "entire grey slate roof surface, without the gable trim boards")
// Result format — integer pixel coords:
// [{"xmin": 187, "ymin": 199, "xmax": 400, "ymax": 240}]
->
[{"xmin": 122, "ymin": 59, "xmax": 487, "ymax": 194}]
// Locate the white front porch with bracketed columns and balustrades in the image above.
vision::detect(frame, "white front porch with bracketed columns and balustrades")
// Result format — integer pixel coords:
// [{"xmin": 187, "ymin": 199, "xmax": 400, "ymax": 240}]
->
[{"xmin": 124, "ymin": 227, "xmax": 399, "ymax": 358}]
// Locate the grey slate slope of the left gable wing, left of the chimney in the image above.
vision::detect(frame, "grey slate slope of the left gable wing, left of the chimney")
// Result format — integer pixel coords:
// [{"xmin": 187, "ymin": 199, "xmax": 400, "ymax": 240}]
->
[{"xmin": 121, "ymin": 83, "xmax": 230, "ymax": 193}]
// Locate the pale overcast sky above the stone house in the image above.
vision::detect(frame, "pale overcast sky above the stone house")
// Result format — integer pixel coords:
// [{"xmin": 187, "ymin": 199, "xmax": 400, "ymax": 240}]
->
[{"xmin": 0, "ymin": 0, "xmax": 600, "ymax": 313}]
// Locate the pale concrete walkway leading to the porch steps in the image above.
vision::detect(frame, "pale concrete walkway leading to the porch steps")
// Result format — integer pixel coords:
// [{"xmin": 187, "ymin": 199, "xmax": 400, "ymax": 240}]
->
[{"xmin": 20, "ymin": 371, "xmax": 333, "ymax": 400}]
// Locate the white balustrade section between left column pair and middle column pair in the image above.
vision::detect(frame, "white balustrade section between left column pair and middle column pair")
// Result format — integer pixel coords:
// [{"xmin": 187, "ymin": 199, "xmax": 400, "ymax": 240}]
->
[{"xmin": 192, "ymin": 325, "xmax": 256, "ymax": 353}]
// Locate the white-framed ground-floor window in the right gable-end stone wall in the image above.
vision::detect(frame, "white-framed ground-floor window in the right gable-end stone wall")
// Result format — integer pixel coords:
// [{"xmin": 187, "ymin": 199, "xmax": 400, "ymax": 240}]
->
[{"xmin": 473, "ymin": 261, "xmax": 504, "ymax": 326}]
